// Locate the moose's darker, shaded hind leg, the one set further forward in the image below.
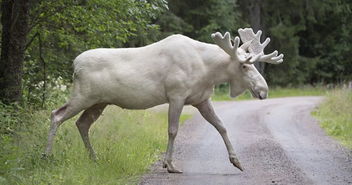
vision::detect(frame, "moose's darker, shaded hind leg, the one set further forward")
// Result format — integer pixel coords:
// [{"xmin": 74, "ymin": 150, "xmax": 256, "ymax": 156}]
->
[{"xmin": 76, "ymin": 104, "xmax": 107, "ymax": 160}]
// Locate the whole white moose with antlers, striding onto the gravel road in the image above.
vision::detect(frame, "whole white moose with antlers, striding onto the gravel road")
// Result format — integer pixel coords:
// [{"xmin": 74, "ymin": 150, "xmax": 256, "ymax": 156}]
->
[{"xmin": 44, "ymin": 28, "xmax": 283, "ymax": 173}]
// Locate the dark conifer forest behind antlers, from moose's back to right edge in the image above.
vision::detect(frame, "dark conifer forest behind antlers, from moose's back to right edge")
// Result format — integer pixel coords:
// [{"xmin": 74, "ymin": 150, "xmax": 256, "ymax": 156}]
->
[{"xmin": 157, "ymin": 0, "xmax": 352, "ymax": 87}]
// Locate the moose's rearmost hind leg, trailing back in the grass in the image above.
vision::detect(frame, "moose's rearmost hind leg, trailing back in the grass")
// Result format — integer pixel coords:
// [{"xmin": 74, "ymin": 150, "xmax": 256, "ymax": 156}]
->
[{"xmin": 43, "ymin": 103, "xmax": 82, "ymax": 156}]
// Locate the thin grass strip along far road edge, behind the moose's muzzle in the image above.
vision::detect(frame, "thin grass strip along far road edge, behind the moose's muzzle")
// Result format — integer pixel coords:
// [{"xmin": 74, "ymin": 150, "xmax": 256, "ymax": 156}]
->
[{"xmin": 212, "ymin": 86, "xmax": 329, "ymax": 101}]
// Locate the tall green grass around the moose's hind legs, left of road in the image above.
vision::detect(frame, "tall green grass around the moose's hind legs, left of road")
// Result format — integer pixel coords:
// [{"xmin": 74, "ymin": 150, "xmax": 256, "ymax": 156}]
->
[{"xmin": 0, "ymin": 100, "xmax": 172, "ymax": 185}]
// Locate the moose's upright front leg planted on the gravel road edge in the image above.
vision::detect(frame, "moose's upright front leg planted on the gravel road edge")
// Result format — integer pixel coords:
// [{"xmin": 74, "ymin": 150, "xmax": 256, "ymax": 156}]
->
[{"xmin": 163, "ymin": 100, "xmax": 184, "ymax": 173}]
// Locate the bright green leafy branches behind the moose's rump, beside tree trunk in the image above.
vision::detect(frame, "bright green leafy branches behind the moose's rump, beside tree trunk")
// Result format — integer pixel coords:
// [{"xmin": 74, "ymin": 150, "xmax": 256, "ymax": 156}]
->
[{"xmin": 24, "ymin": 0, "xmax": 167, "ymax": 107}]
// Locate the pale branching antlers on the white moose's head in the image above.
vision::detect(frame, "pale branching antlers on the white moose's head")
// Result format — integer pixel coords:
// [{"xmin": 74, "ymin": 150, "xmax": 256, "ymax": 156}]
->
[{"xmin": 211, "ymin": 28, "xmax": 284, "ymax": 64}]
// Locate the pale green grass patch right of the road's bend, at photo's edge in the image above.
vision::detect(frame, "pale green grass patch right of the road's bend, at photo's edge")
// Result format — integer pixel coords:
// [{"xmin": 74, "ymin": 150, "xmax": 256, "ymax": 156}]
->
[{"xmin": 312, "ymin": 89, "xmax": 352, "ymax": 149}]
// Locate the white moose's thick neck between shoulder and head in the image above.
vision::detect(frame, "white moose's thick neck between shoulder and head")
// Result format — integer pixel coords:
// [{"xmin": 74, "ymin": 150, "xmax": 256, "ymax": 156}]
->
[{"xmin": 199, "ymin": 43, "xmax": 238, "ymax": 85}]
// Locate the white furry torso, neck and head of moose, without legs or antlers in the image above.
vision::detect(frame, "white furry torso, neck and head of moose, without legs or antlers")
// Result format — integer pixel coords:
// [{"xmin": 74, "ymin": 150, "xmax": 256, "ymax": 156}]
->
[{"xmin": 73, "ymin": 35, "xmax": 266, "ymax": 109}]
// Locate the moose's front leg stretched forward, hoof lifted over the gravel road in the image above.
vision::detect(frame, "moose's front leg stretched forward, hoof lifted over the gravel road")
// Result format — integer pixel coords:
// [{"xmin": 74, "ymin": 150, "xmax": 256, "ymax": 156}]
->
[{"xmin": 194, "ymin": 99, "xmax": 243, "ymax": 171}]
